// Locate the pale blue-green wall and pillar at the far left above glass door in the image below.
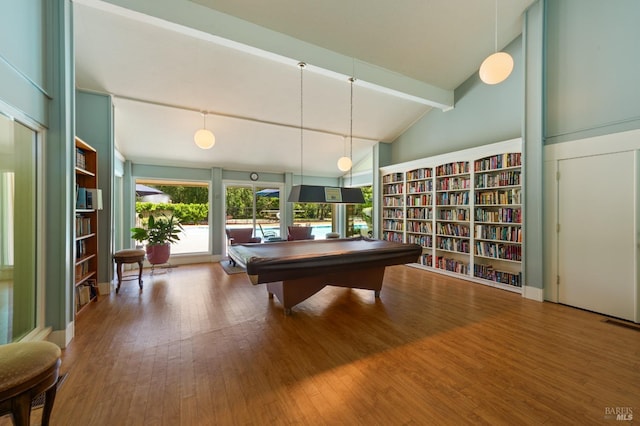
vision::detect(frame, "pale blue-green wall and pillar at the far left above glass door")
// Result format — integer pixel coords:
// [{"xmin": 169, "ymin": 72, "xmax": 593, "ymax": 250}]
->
[{"xmin": 0, "ymin": 0, "xmax": 75, "ymax": 345}]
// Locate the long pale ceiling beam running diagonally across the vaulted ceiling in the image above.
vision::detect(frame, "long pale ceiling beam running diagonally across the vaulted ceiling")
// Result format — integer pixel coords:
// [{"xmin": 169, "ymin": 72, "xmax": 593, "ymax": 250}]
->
[{"xmin": 75, "ymin": 0, "xmax": 454, "ymax": 110}]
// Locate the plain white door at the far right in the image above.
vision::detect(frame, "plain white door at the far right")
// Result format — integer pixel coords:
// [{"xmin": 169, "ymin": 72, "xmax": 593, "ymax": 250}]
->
[{"xmin": 558, "ymin": 151, "xmax": 636, "ymax": 321}]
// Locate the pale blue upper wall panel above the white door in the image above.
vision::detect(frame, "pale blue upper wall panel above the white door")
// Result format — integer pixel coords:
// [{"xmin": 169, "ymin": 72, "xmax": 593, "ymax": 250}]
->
[{"xmin": 546, "ymin": 0, "xmax": 640, "ymax": 144}]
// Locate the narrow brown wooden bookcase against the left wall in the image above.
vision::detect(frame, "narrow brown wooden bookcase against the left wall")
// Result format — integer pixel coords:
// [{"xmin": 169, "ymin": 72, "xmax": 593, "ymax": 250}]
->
[{"xmin": 74, "ymin": 137, "xmax": 99, "ymax": 315}]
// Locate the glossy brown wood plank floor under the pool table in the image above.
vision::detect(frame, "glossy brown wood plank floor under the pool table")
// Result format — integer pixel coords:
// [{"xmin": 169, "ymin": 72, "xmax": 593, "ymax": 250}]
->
[{"xmin": 0, "ymin": 263, "xmax": 640, "ymax": 426}]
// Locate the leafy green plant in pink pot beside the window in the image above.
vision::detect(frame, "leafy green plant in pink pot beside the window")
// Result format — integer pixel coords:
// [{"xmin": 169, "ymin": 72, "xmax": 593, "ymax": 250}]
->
[{"xmin": 131, "ymin": 214, "xmax": 183, "ymax": 265}]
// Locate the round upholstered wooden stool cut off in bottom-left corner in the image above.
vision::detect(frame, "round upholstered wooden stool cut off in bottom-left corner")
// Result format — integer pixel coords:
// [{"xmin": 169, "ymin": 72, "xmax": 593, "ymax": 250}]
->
[{"xmin": 0, "ymin": 342, "xmax": 61, "ymax": 426}]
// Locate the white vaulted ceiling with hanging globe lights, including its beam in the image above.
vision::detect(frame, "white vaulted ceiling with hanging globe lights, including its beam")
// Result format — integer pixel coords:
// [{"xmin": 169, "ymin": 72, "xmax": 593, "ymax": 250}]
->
[{"xmin": 74, "ymin": 0, "xmax": 535, "ymax": 177}]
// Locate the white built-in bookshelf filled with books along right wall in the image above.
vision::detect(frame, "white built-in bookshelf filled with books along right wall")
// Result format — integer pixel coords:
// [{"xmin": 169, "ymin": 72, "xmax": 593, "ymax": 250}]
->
[{"xmin": 381, "ymin": 139, "xmax": 523, "ymax": 292}]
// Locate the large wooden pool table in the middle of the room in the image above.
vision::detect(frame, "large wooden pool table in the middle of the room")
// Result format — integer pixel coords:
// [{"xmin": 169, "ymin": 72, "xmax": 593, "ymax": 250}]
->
[{"xmin": 228, "ymin": 237, "xmax": 422, "ymax": 315}]
